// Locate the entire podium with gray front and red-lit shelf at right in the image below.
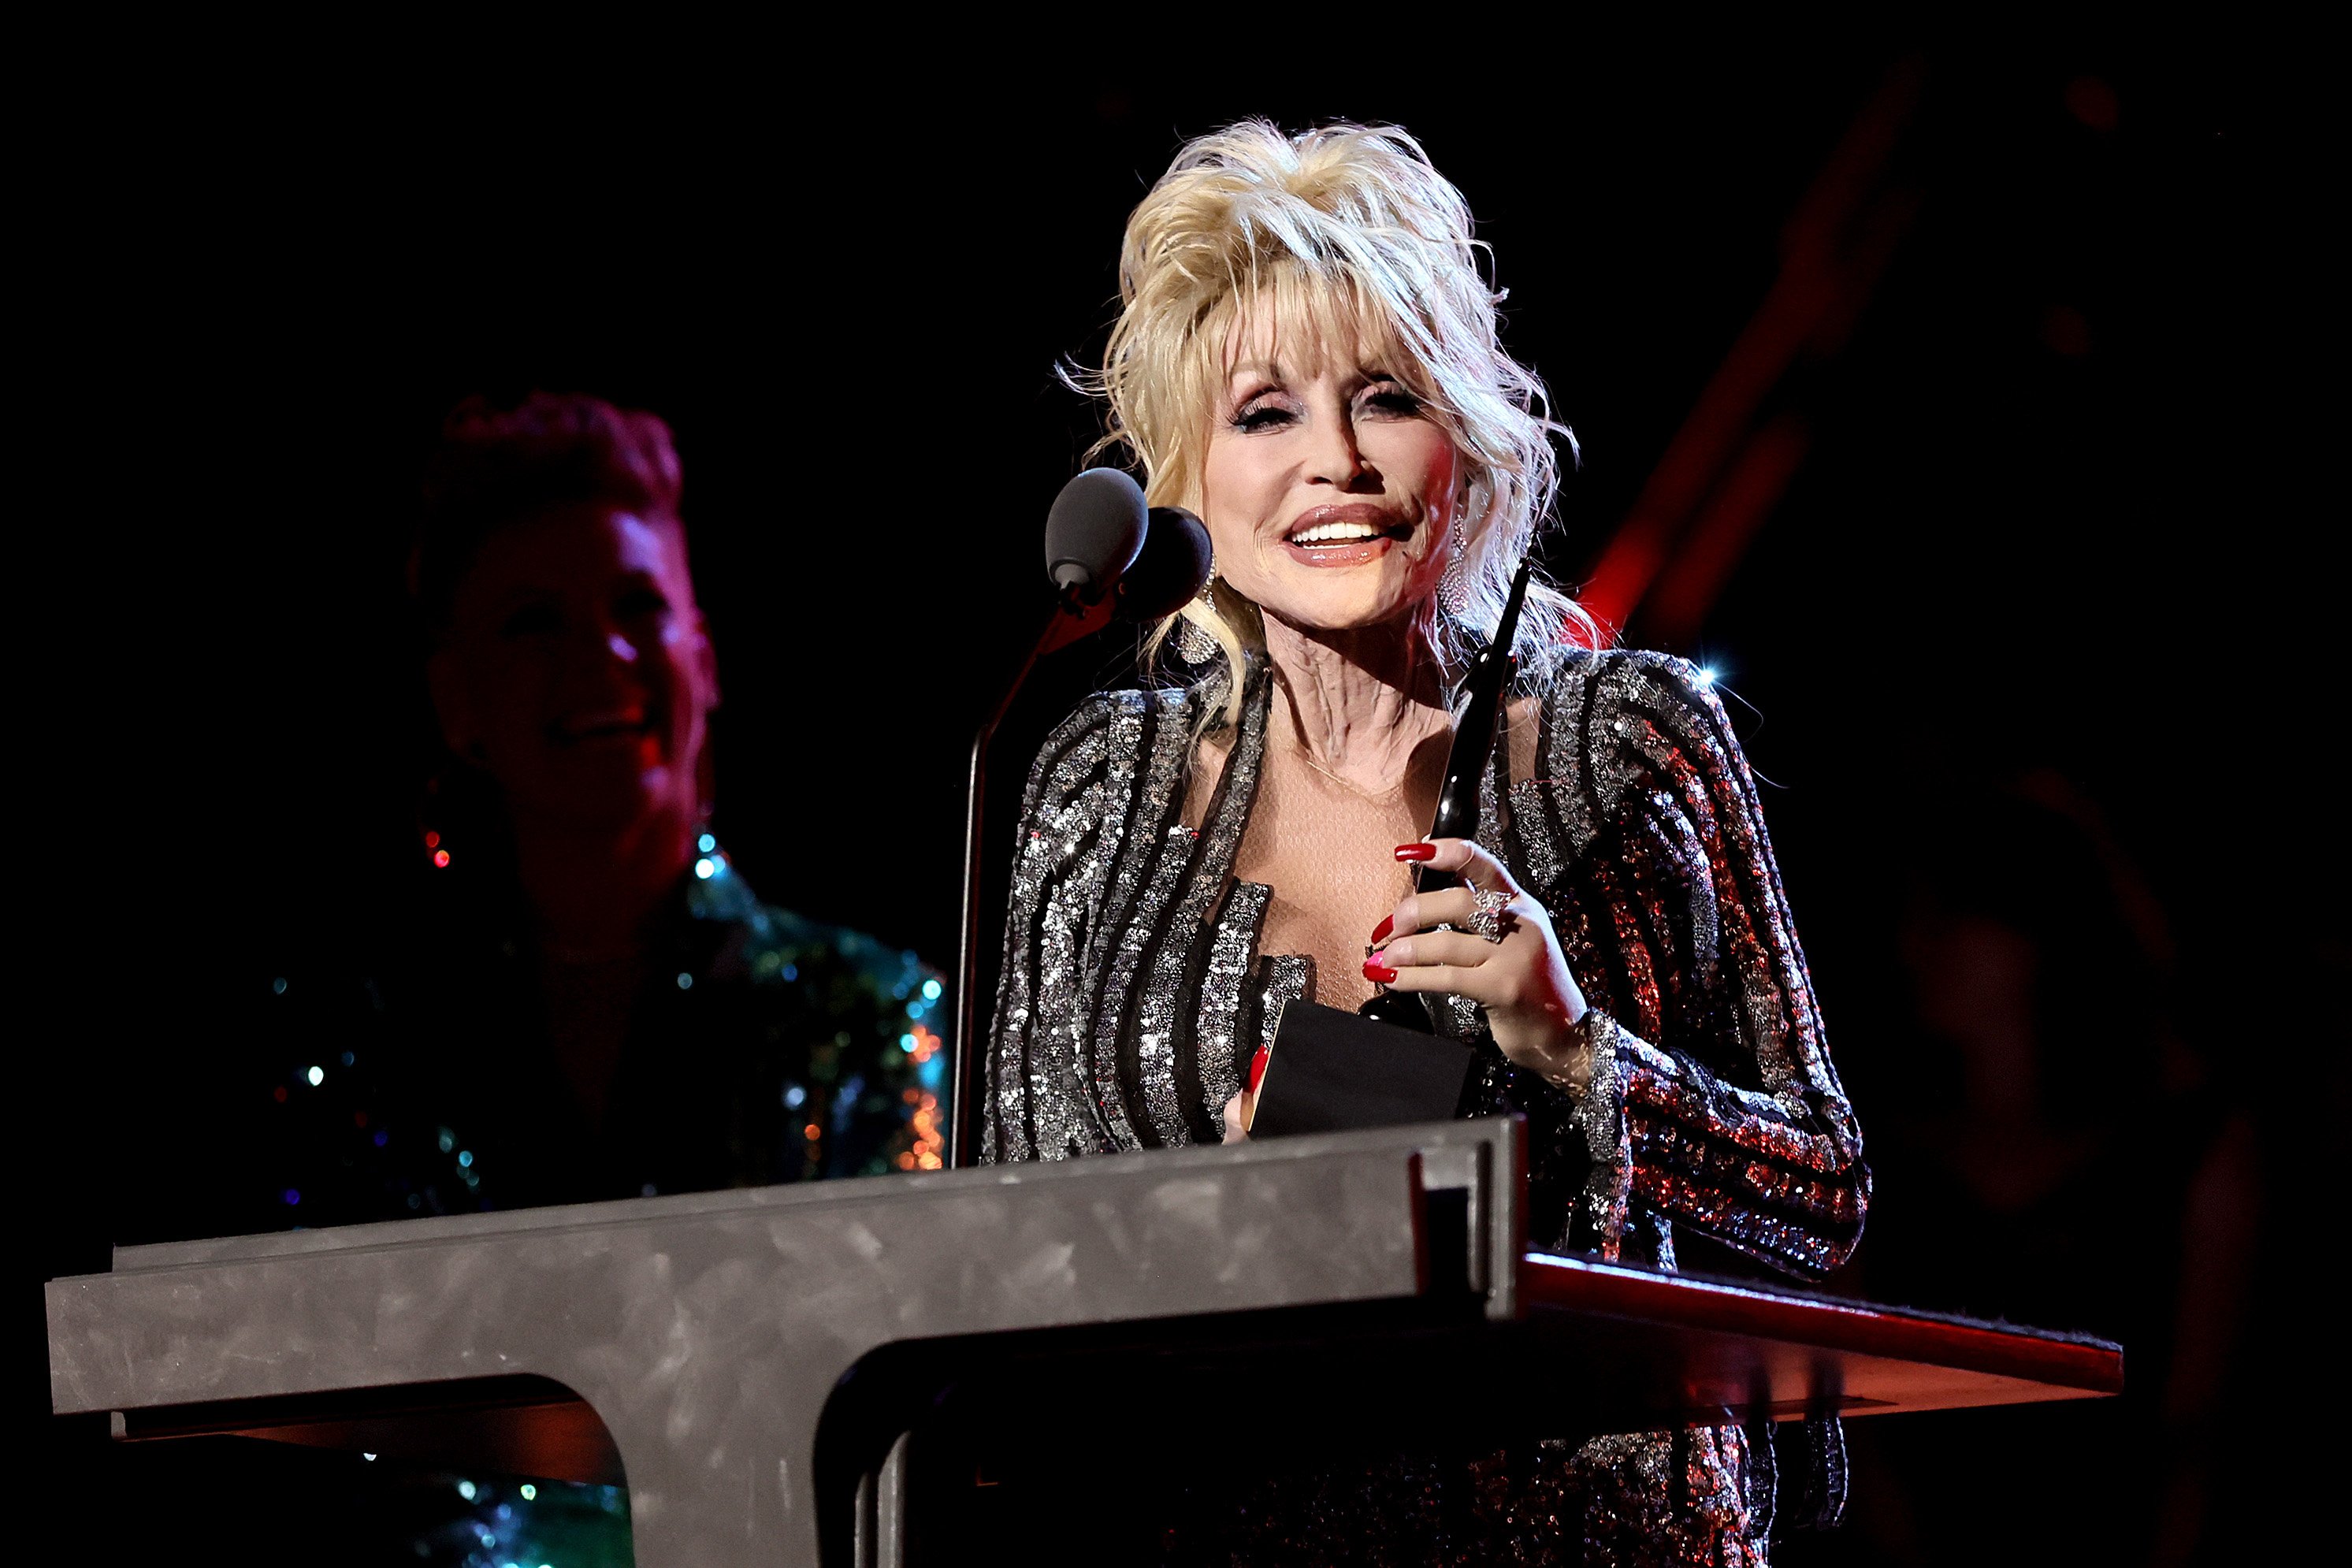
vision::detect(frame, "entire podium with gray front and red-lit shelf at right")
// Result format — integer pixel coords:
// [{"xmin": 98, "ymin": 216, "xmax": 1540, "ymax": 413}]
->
[{"xmin": 47, "ymin": 1119, "xmax": 2121, "ymax": 1568}]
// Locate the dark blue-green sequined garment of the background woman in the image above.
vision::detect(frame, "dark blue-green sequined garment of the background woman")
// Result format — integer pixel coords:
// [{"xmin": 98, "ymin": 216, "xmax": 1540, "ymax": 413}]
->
[{"xmin": 234, "ymin": 842, "xmax": 948, "ymax": 1568}]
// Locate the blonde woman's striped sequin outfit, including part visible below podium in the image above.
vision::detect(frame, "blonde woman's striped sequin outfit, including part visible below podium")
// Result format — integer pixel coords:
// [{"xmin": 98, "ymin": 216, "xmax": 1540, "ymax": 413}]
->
[{"xmin": 983, "ymin": 651, "xmax": 1870, "ymax": 1566}]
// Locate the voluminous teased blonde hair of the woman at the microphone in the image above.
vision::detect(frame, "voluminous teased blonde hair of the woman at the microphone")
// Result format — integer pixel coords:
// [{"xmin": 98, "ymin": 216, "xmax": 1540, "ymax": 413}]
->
[{"xmin": 1079, "ymin": 120, "xmax": 1600, "ymax": 724}]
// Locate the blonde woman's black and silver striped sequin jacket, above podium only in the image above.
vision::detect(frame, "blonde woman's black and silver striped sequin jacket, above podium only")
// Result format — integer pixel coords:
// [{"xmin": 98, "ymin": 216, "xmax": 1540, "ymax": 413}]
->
[{"xmin": 983, "ymin": 651, "xmax": 1870, "ymax": 1274}]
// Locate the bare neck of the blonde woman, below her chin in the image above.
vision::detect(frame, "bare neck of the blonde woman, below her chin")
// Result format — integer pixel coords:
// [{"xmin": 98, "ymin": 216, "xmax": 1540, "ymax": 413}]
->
[{"xmin": 1265, "ymin": 616, "xmax": 1451, "ymax": 792}]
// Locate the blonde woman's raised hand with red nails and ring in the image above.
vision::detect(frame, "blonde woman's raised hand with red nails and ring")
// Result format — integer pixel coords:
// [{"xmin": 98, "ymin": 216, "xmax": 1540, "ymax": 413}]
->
[{"xmin": 1364, "ymin": 839, "xmax": 1592, "ymax": 1093}]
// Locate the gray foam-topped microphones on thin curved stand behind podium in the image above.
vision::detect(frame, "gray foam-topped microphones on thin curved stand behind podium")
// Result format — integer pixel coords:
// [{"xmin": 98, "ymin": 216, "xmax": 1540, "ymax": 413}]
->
[{"xmin": 948, "ymin": 468, "xmax": 1209, "ymax": 1171}]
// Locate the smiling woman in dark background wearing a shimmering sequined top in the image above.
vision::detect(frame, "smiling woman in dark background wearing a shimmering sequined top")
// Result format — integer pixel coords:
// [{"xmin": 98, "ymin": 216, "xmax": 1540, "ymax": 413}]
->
[{"xmin": 238, "ymin": 395, "xmax": 946, "ymax": 1563}]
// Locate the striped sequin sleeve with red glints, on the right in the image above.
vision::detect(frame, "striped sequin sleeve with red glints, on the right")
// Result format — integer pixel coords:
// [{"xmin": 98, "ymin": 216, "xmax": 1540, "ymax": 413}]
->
[{"xmin": 1512, "ymin": 651, "xmax": 1870, "ymax": 1272}]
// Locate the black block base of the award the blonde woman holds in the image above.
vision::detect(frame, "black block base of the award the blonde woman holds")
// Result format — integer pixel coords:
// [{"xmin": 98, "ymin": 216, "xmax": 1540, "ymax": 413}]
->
[{"xmin": 1249, "ymin": 1001, "xmax": 1470, "ymax": 1138}]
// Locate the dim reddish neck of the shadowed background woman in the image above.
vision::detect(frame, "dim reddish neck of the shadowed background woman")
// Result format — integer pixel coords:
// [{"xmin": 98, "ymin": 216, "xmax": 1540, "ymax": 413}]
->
[{"xmin": 515, "ymin": 811, "xmax": 694, "ymax": 964}]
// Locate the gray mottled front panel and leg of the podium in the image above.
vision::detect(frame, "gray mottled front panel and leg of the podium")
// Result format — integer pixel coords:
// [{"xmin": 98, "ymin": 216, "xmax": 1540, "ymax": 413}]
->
[{"xmin": 47, "ymin": 1121, "xmax": 1519, "ymax": 1568}]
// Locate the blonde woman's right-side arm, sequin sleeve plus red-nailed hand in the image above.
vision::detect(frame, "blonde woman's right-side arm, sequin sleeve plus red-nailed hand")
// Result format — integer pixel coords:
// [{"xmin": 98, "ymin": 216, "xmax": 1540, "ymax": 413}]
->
[{"xmin": 1366, "ymin": 653, "xmax": 1870, "ymax": 1272}]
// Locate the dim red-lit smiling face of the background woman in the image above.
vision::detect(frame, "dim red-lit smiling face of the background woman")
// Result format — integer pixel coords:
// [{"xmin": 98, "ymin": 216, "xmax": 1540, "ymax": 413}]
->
[{"xmin": 430, "ymin": 503, "xmax": 717, "ymax": 832}]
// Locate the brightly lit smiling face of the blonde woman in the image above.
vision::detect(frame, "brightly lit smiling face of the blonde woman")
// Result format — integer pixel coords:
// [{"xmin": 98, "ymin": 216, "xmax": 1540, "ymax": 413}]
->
[{"xmin": 1199, "ymin": 310, "xmax": 1463, "ymax": 630}]
